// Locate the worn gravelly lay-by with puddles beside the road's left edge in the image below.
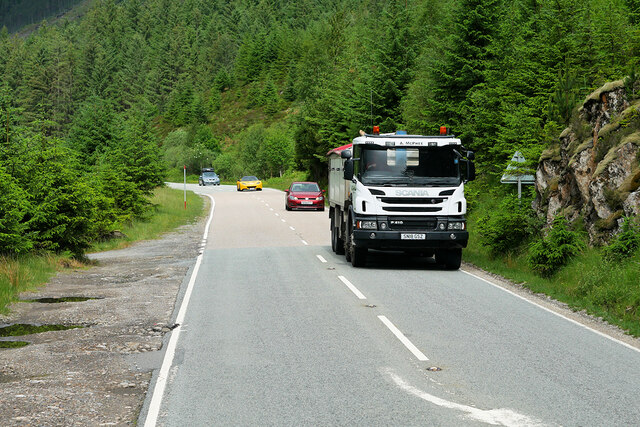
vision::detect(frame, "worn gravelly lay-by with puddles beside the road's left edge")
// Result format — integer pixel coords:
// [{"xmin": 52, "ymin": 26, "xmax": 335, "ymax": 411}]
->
[{"xmin": 0, "ymin": 212, "xmax": 206, "ymax": 426}]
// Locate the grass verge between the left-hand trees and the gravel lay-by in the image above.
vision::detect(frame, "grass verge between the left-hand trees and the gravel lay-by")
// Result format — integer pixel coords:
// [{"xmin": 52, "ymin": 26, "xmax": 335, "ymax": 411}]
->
[{"xmin": 0, "ymin": 188, "xmax": 204, "ymax": 313}]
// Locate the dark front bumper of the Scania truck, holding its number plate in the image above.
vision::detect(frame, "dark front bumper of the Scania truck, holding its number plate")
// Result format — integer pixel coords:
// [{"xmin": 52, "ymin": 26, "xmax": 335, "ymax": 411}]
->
[{"xmin": 353, "ymin": 230, "xmax": 469, "ymax": 250}]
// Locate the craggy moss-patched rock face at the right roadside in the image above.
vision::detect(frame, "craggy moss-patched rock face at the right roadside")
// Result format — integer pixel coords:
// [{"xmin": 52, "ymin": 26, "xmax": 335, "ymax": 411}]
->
[{"xmin": 534, "ymin": 80, "xmax": 640, "ymax": 244}]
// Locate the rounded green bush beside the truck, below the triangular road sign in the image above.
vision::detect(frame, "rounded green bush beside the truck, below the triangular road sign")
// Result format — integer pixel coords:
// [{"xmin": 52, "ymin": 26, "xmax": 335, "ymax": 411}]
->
[{"xmin": 478, "ymin": 195, "xmax": 537, "ymax": 255}]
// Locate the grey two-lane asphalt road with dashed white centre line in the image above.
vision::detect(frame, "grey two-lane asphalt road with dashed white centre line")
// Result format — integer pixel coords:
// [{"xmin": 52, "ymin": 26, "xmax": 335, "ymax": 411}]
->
[{"xmin": 140, "ymin": 186, "xmax": 640, "ymax": 426}]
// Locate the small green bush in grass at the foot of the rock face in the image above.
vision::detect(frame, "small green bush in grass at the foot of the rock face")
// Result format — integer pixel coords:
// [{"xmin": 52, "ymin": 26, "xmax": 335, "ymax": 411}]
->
[{"xmin": 528, "ymin": 215, "xmax": 584, "ymax": 277}]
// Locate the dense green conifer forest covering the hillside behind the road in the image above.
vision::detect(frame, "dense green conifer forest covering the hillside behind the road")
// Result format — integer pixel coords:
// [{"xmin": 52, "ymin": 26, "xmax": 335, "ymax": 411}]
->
[{"xmin": 0, "ymin": 0, "xmax": 640, "ymax": 254}]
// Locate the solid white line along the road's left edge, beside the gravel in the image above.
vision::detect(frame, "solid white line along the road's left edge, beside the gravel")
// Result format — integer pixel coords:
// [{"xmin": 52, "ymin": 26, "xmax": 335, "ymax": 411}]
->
[{"xmin": 144, "ymin": 194, "xmax": 216, "ymax": 427}]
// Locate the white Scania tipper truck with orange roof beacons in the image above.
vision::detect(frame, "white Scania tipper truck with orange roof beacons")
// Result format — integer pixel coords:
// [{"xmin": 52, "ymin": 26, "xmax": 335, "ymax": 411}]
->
[{"xmin": 327, "ymin": 126, "xmax": 475, "ymax": 269}]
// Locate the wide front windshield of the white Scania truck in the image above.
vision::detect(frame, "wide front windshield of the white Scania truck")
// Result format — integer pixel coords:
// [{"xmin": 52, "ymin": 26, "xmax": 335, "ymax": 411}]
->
[{"xmin": 359, "ymin": 146, "xmax": 460, "ymax": 186}]
